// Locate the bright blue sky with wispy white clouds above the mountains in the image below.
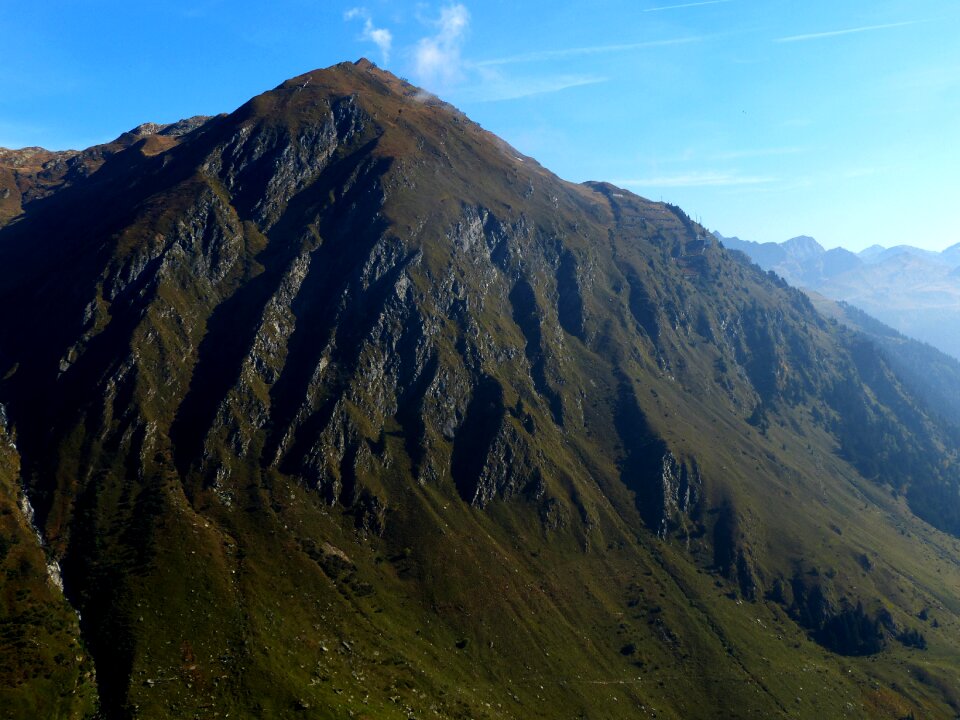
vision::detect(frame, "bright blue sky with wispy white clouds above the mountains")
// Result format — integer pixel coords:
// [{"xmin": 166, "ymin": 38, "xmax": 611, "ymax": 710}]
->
[{"xmin": 0, "ymin": 0, "xmax": 960, "ymax": 250}]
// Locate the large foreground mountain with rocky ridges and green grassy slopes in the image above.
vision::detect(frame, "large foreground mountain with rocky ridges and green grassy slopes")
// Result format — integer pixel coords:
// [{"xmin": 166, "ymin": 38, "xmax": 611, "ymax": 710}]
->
[{"xmin": 0, "ymin": 61, "xmax": 960, "ymax": 719}]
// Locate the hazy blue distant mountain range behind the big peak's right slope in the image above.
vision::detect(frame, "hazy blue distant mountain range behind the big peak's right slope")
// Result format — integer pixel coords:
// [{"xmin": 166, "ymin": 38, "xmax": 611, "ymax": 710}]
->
[{"xmin": 714, "ymin": 232, "xmax": 960, "ymax": 358}]
